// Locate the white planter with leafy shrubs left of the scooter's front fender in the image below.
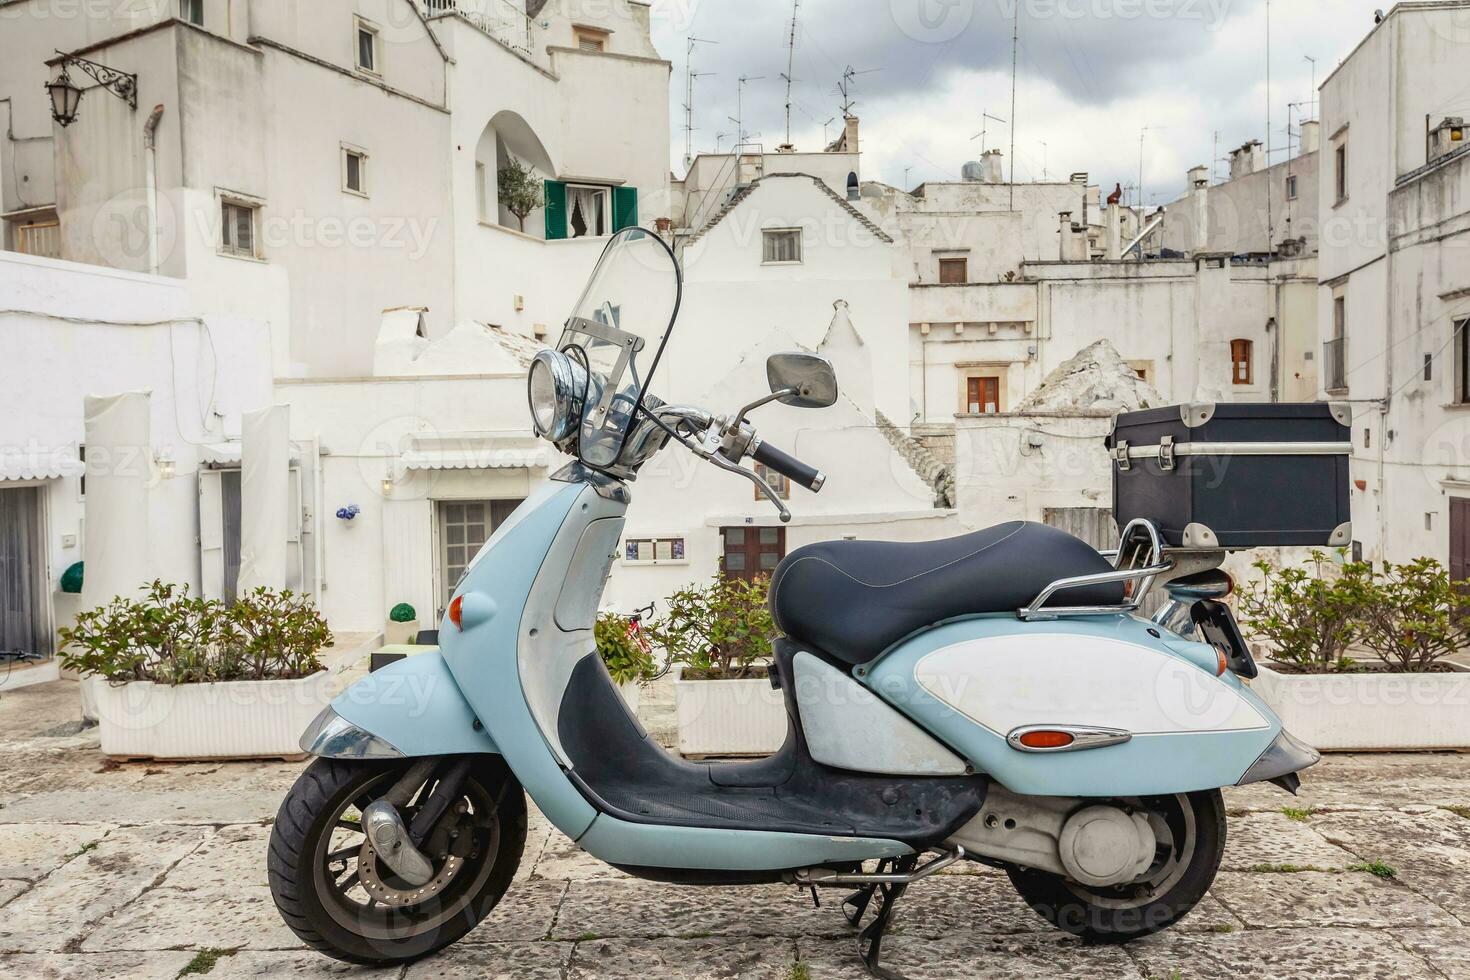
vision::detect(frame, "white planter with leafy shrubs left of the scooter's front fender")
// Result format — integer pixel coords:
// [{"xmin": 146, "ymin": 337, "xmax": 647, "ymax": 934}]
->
[{"xmin": 59, "ymin": 582, "xmax": 332, "ymax": 758}]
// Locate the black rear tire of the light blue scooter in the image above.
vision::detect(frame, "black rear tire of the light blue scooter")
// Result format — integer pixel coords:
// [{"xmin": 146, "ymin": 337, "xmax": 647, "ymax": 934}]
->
[{"xmin": 1007, "ymin": 789, "xmax": 1225, "ymax": 943}]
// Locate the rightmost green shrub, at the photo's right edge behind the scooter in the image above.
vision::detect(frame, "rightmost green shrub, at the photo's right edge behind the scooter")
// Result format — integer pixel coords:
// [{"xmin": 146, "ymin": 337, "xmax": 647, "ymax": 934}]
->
[{"xmin": 1358, "ymin": 558, "xmax": 1470, "ymax": 671}]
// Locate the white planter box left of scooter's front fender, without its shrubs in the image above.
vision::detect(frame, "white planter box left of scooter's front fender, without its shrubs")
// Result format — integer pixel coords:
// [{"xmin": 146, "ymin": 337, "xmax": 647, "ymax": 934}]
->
[{"xmin": 93, "ymin": 670, "xmax": 335, "ymax": 758}]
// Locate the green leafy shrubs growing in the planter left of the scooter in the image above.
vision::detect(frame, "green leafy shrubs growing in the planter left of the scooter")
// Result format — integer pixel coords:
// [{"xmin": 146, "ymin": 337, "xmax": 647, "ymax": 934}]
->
[{"xmin": 59, "ymin": 580, "xmax": 332, "ymax": 685}]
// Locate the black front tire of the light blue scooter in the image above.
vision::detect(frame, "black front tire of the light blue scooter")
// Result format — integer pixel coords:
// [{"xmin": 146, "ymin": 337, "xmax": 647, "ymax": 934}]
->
[{"xmin": 266, "ymin": 755, "xmax": 526, "ymax": 965}]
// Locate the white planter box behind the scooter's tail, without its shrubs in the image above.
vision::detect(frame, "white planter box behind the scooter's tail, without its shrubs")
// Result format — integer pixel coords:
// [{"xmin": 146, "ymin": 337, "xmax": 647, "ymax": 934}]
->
[{"xmin": 1251, "ymin": 664, "xmax": 1470, "ymax": 752}]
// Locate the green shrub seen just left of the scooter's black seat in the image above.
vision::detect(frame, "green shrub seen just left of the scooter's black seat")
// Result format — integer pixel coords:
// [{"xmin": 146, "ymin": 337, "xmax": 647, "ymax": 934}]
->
[{"xmin": 647, "ymin": 574, "xmax": 776, "ymax": 680}]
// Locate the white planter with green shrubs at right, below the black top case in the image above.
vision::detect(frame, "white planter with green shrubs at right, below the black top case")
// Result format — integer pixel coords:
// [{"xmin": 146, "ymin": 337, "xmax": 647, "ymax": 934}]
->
[{"xmin": 1241, "ymin": 552, "xmax": 1470, "ymax": 749}]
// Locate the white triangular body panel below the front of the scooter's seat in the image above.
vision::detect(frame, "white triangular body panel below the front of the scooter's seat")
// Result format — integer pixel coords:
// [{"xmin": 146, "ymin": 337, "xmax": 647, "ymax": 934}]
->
[{"xmin": 792, "ymin": 652, "xmax": 966, "ymax": 776}]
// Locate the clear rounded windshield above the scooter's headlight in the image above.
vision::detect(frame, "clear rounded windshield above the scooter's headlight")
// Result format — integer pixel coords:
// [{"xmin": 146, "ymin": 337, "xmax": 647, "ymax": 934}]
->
[{"xmin": 557, "ymin": 228, "xmax": 681, "ymax": 467}]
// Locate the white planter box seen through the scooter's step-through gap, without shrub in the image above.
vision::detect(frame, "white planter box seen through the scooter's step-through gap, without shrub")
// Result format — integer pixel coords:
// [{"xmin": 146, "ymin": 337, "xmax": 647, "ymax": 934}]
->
[{"xmin": 673, "ymin": 667, "xmax": 786, "ymax": 755}]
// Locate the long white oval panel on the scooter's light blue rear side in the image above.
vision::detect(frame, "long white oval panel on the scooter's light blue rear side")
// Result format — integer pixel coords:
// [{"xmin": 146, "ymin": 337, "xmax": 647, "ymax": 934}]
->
[{"xmin": 914, "ymin": 633, "xmax": 1267, "ymax": 736}]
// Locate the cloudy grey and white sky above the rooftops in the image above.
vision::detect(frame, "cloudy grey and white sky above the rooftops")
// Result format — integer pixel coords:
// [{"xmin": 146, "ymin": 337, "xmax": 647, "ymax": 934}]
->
[{"xmin": 653, "ymin": 0, "xmax": 1391, "ymax": 203}]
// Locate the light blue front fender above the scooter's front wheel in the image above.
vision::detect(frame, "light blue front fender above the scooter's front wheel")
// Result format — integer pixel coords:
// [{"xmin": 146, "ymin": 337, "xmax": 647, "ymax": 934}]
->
[{"xmin": 301, "ymin": 649, "xmax": 500, "ymax": 758}]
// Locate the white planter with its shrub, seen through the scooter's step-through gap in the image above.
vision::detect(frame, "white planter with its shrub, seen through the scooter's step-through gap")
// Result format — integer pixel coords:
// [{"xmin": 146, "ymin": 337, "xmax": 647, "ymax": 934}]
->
[{"xmin": 648, "ymin": 574, "xmax": 786, "ymax": 755}]
